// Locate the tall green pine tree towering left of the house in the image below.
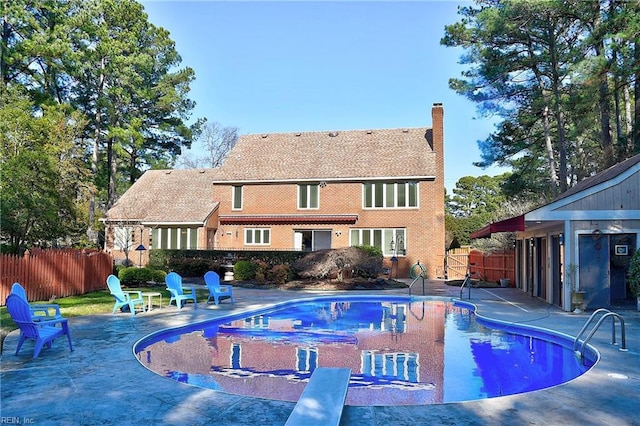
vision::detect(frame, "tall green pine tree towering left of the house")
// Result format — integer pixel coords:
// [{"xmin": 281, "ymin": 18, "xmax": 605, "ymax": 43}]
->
[{"xmin": 0, "ymin": 0, "xmax": 200, "ymax": 245}]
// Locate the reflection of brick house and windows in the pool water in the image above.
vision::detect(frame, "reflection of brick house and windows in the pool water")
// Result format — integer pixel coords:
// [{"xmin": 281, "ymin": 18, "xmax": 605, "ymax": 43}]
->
[{"xmin": 138, "ymin": 301, "xmax": 450, "ymax": 405}]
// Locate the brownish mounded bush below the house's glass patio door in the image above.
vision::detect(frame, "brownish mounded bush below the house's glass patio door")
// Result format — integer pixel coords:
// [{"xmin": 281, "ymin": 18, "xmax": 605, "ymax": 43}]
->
[{"xmin": 292, "ymin": 246, "xmax": 383, "ymax": 279}]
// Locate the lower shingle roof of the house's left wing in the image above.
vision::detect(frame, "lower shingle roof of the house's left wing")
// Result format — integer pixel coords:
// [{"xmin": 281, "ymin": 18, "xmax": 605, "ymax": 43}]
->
[{"xmin": 107, "ymin": 169, "xmax": 218, "ymax": 223}]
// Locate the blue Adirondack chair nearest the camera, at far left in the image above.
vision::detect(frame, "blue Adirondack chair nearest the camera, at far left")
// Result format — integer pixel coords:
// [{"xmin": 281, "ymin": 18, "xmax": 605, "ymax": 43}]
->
[{"xmin": 6, "ymin": 293, "xmax": 73, "ymax": 358}]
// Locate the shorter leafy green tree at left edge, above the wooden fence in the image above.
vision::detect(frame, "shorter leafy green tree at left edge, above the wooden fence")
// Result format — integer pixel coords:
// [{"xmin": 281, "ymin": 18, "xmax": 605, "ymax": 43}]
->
[{"xmin": 0, "ymin": 89, "xmax": 88, "ymax": 253}]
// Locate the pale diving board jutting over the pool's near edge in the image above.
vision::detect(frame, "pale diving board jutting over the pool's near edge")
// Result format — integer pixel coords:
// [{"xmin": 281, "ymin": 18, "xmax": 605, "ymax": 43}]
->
[{"xmin": 285, "ymin": 367, "xmax": 351, "ymax": 426}]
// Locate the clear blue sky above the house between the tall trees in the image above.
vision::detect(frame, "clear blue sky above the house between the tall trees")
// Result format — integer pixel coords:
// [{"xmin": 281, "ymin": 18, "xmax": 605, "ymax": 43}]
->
[{"xmin": 142, "ymin": 0, "xmax": 504, "ymax": 192}]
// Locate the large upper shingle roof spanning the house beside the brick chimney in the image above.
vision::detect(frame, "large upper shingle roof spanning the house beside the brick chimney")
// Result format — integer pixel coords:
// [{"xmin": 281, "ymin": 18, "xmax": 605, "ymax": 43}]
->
[{"xmin": 209, "ymin": 127, "xmax": 437, "ymax": 181}]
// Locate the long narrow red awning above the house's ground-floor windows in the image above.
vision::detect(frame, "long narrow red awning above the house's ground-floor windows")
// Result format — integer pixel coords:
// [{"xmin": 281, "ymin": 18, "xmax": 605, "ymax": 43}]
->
[{"xmin": 219, "ymin": 214, "xmax": 358, "ymax": 225}]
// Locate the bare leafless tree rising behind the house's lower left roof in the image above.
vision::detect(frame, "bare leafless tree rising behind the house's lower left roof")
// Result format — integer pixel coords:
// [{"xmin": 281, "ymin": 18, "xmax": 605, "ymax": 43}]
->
[{"xmin": 178, "ymin": 122, "xmax": 238, "ymax": 169}]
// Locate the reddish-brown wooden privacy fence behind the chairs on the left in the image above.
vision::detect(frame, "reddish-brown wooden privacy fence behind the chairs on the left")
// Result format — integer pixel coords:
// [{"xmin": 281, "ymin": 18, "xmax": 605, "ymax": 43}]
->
[{"xmin": 0, "ymin": 249, "xmax": 113, "ymax": 306}]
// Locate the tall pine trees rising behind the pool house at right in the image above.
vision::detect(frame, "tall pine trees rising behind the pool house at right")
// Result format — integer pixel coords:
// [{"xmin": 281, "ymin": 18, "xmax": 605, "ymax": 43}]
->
[{"xmin": 441, "ymin": 0, "xmax": 640, "ymax": 195}]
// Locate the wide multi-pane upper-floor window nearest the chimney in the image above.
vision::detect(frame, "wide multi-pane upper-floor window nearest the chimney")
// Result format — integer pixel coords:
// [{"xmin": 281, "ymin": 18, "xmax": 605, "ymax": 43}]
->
[{"xmin": 363, "ymin": 182, "xmax": 418, "ymax": 209}]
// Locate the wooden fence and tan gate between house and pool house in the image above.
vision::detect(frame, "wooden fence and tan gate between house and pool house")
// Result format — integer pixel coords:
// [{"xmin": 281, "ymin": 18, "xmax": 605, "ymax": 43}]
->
[{"xmin": 446, "ymin": 248, "xmax": 516, "ymax": 285}]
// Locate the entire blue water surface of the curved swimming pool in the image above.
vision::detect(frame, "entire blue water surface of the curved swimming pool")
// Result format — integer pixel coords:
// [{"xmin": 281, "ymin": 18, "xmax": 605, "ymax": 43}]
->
[{"xmin": 134, "ymin": 297, "xmax": 597, "ymax": 406}]
